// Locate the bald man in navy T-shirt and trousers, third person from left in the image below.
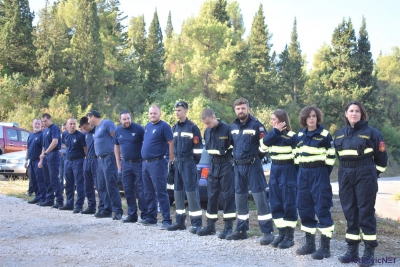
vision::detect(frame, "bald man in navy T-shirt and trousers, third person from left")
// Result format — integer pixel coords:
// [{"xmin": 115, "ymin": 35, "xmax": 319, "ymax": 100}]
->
[{"xmin": 58, "ymin": 118, "xmax": 86, "ymax": 213}]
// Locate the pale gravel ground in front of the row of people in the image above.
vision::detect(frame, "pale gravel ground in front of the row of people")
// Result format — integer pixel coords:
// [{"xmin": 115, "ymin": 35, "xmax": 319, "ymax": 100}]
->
[{"xmin": 0, "ymin": 195, "xmax": 398, "ymax": 267}]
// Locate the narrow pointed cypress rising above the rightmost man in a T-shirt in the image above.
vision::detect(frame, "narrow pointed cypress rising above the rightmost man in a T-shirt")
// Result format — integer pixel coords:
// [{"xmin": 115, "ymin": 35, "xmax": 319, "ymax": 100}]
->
[{"xmin": 144, "ymin": 11, "xmax": 165, "ymax": 100}]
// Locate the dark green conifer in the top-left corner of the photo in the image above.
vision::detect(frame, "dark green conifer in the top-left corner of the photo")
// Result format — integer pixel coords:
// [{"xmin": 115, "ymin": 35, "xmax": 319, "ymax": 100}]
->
[{"xmin": 0, "ymin": 0, "xmax": 36, "ymax": 76}]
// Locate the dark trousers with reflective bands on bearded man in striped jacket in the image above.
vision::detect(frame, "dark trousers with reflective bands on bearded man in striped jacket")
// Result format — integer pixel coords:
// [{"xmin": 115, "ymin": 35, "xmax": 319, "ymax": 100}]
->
[{"xmin": 234, "ymin": 159, "xmax": 274, "ymax": 233}]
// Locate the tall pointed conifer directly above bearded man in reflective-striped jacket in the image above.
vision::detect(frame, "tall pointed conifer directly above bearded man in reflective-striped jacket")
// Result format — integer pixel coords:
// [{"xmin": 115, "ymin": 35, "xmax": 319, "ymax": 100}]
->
[{"xmin": 246, "ymin": 4, "xmax": 276, "ymax": 105}]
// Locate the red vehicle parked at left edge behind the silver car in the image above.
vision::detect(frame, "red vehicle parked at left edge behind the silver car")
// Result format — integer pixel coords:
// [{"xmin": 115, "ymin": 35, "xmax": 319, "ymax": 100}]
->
[{"xmin": 0, "ymin": 122, "xmax": 30, "ymax": 155}]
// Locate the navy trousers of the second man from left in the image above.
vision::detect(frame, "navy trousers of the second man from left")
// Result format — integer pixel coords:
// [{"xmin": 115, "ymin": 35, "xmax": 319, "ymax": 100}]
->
[{"xmin": 43, "ymin": 151, "xmax": 64, "ymax": 205}]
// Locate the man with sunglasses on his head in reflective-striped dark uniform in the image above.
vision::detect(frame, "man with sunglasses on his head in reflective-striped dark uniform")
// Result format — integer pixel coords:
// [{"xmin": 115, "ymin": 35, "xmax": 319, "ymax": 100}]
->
[{"xmin": 167, "ymin": 101, "xmax": 203, "ymax": 234}]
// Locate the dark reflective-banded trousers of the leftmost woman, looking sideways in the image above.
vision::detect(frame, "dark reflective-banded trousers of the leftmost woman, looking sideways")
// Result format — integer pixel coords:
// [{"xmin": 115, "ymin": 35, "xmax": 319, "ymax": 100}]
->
[{"xmin": 269, "ymin": 164, "xmax": 297, "ymax": 228}]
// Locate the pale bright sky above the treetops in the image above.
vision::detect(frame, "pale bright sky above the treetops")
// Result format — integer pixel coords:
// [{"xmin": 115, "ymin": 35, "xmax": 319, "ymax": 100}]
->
[{"xmin": 29, "ymin": 0, "xmax": 400, "ymax": 68}]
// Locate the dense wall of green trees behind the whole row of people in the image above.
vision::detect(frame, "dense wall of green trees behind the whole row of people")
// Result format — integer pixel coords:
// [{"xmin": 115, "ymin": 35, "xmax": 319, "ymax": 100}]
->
[{"xmin": 0, "ymin": 0, "xmax": 400, "ymax": 163}]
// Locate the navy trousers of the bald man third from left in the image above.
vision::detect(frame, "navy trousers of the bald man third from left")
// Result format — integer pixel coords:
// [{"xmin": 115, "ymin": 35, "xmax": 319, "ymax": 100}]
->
[{"xmin": 64, "ymin": 158, "xmax": 85, "ymax": 209}]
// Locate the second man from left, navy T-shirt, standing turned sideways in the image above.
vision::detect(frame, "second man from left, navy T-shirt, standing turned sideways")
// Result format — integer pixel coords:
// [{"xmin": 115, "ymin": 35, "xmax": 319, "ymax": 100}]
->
[{"xmin": 39, "ymin": 113, "xmax": 64, "ymax": 209}]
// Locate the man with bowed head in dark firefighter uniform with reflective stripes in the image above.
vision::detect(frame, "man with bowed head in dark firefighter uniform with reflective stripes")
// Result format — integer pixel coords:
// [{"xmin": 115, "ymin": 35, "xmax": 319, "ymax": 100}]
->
[{"xmin": 197, "ymin": 108, "xmax": 236, "ymax": 239}]
